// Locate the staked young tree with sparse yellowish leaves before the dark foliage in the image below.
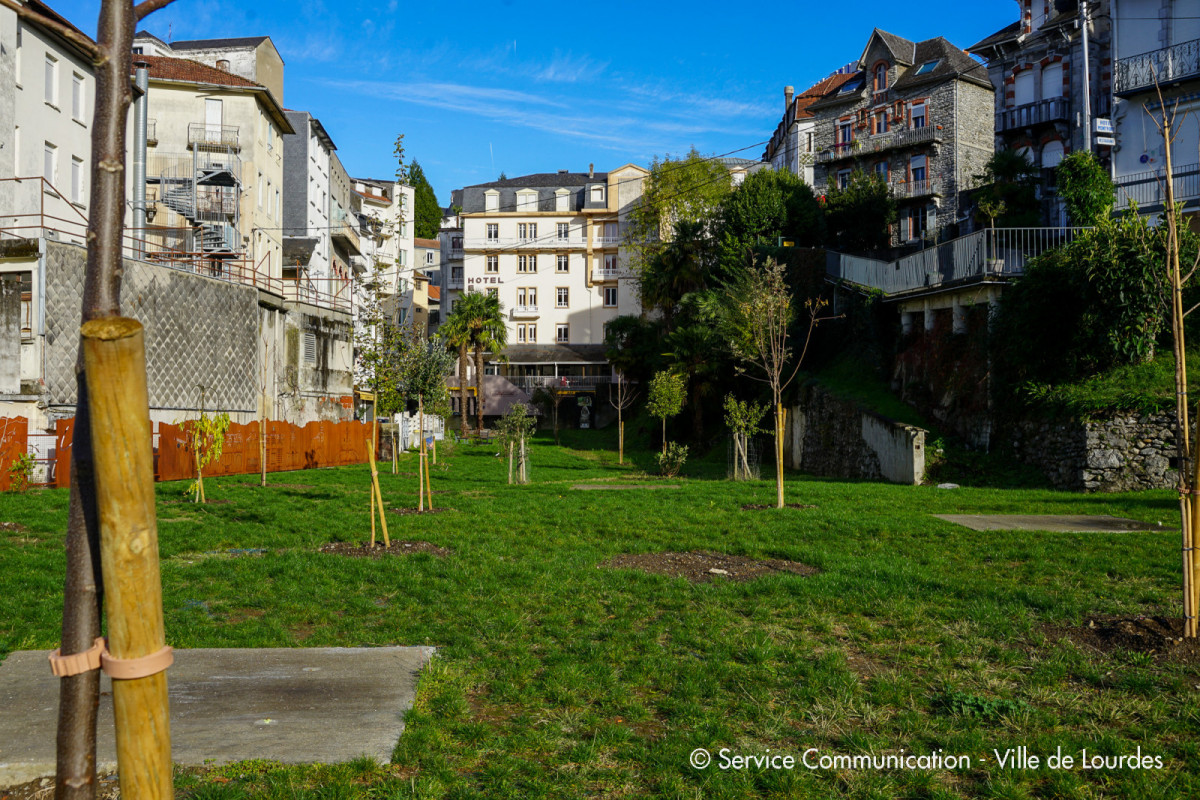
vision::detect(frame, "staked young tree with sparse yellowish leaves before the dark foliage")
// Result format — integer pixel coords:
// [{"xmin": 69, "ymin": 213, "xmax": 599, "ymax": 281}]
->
[{"xmin": 724, "ymin": 260, "xmax": 826, "ymax": 509}]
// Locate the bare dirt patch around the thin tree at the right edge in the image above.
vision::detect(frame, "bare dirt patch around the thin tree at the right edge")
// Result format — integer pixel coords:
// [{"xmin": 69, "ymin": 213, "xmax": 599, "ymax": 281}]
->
[{"xmin": 1042, "ymin": 615, "xmax": 1200, "ymax": 666}]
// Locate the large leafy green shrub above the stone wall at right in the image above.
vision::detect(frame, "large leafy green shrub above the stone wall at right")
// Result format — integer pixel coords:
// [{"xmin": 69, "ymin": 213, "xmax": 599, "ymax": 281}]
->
[{"xmin": 995, "ymin": 213, "xmax": 1176, "ymax": 397}]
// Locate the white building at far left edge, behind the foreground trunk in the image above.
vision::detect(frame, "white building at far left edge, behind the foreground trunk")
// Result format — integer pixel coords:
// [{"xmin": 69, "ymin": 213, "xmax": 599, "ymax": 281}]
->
[{"xmin": 0, "ymin": 0, "xmax": 96, "ymax": 242}]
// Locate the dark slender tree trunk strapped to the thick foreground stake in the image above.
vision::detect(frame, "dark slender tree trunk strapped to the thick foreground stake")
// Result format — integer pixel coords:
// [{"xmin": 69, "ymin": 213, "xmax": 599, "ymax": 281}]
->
[{"xmin": 4, "ymin": 0, "xmax": 182, "ymax": 800}]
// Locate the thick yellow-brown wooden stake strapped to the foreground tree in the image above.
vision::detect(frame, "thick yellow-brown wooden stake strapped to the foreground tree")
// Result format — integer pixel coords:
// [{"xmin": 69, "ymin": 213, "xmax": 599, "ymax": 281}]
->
[{"xmin": 80, "ymin": 317, "xmax": 174, "ymax": 800}]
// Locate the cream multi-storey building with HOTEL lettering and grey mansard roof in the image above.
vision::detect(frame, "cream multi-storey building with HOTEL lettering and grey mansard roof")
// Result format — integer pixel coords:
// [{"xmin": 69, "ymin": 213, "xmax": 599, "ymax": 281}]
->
[{"xmin": 450, "ymin": 164, "xmax": 649, "ymax": 379}]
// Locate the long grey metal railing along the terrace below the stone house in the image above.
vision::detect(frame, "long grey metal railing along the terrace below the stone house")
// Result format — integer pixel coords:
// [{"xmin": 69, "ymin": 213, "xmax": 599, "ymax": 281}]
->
[{"xmin": 826, "ymin": 228, "xmax": 1086, "ymax": 294}]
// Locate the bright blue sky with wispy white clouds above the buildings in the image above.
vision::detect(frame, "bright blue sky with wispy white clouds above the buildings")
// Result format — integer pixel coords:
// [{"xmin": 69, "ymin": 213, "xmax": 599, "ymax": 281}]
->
[{"xmin": 50, "ymin": 0, "xmax": 1018, "ymax": 204}]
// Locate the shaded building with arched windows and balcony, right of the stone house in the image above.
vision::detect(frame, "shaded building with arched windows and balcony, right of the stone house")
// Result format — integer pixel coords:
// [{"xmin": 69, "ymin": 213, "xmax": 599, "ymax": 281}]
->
[{"xmin": 967, "ymin": 0, "xmax": 1112, "ymax": 224}]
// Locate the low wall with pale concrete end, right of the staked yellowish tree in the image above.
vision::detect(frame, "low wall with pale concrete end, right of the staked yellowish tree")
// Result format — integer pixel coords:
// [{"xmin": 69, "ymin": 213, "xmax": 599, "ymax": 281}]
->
[{"xmin": 784, "ymin": 385, "xmax": 926, "ymax": 485}]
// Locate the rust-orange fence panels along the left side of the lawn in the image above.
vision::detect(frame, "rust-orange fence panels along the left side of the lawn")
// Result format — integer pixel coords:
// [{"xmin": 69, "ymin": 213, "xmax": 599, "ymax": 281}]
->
[{"xmin": 0, "ymin": 416, "xmax": 372, "ymax": 491}]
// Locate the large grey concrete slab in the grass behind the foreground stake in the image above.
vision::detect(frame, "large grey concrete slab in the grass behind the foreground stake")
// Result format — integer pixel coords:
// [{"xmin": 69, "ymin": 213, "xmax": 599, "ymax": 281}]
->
[{"xmin": 0, "ymin": 648, "xmax": 433, "ymax": 788}]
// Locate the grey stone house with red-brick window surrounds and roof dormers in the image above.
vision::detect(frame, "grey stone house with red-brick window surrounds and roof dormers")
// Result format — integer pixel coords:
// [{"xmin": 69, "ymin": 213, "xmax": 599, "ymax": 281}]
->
[{"xmin": 808, "ymin": 29, "xmax": 995, "ymax": 243}]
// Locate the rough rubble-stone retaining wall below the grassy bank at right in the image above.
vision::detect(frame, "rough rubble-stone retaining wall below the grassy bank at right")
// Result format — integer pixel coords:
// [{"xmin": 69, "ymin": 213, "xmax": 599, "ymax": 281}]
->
[{"xmin": 1002, "ymin": 414, "xmax": 1177, "ymax": 492}]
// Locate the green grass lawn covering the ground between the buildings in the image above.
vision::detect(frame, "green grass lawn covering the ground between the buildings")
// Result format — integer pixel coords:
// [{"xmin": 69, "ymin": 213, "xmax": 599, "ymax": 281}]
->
[{"xmin": 0, "ymin": 432, "xmax": 1200, "ymax": 799}]
